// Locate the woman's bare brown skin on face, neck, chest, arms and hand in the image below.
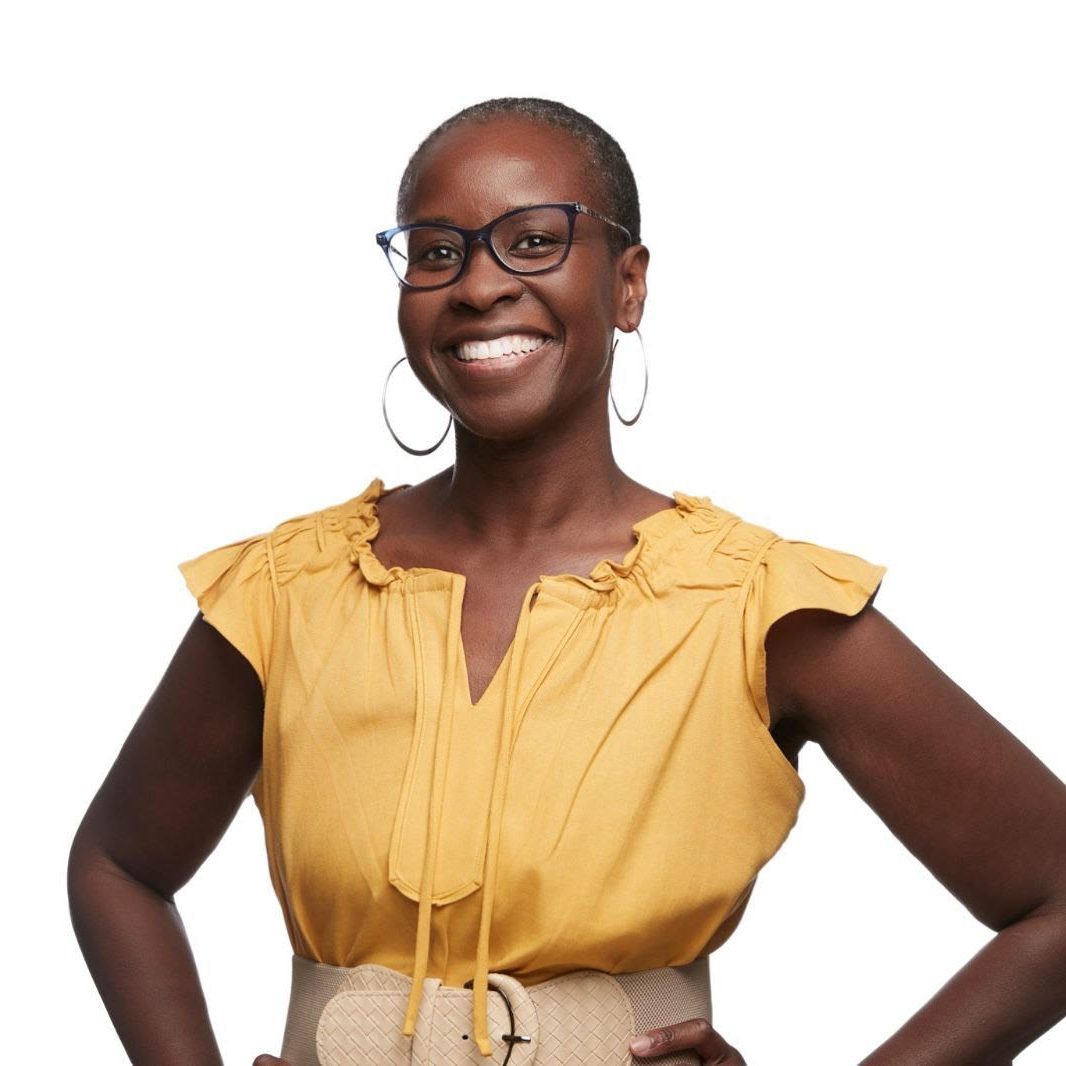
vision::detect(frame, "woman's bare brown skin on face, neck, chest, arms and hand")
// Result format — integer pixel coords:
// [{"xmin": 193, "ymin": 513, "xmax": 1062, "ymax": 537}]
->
[{"xmin": 68, "ymin": 112, "xmax": 1066, "ymax": 1066}]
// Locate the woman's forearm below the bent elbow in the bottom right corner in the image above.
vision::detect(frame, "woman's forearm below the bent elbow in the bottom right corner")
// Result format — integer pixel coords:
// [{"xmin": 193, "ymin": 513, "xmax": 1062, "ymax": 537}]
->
[{"xmin": 859, "ymin": 910, "xmax": 1066, "ymax": 1066}]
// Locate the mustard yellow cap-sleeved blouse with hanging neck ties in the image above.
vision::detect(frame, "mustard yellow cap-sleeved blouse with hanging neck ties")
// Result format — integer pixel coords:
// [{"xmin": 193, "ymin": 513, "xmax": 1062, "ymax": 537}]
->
[{"xmin": 179, "ymin": 478, "xmax": 886, "ymax": 1055}]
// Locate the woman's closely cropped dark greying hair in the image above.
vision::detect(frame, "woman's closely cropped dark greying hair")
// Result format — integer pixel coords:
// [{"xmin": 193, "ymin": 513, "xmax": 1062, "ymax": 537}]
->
[{"xmin": 397, "ymin": 96, "xmax": 641, "ymax": 257}]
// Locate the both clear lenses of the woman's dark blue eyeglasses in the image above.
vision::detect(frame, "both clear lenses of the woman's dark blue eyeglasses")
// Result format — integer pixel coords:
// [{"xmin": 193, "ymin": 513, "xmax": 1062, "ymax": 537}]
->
[{"xmin": 388, "ymin": 207, "xmax": 570, "ymax": 288}]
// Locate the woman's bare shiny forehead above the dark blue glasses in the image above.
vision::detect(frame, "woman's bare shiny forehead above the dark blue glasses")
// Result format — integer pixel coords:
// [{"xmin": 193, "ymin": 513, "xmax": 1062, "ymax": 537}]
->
[{"xmin": 401, "ymin": 117, "xmax": 600, "ymax": 227}]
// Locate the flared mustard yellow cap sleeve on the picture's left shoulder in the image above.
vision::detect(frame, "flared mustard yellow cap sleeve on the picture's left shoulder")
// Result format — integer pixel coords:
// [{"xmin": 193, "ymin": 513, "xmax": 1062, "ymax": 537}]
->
[{"xmin": 178, "ymin": 534, "xmax": 277, "ymax": 690}]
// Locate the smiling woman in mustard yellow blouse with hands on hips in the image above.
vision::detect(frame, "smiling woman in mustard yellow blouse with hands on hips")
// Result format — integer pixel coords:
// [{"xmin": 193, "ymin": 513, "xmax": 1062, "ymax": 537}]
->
[{"xmin": 70, "ymin": 98, "xmax": 1066, "ymax": 1066}]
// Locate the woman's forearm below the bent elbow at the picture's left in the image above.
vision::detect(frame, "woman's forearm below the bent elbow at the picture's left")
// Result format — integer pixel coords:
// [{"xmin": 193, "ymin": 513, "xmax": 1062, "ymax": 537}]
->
[{"xmin": 67, "ymin": 845, "xmax": 222, "ymax": 1066}]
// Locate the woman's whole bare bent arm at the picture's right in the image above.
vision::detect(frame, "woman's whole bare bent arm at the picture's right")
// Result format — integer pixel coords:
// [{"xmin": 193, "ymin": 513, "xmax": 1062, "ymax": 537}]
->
[{"xmin": 766, "ymin": 605, "xmax": 1066, "ymax": 1066}]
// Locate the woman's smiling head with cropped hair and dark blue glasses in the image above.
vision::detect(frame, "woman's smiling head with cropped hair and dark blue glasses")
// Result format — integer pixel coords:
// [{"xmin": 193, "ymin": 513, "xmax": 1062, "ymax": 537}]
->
[{"xmin": 377, "ymin": 104, "xmax": 649, "ymax": 454}]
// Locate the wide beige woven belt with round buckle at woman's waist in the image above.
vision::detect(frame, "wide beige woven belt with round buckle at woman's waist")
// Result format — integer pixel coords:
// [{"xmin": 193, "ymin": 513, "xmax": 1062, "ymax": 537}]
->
[{"xmin": 281, "ymin": 955, "xmax": 711, "ymax": 1066}]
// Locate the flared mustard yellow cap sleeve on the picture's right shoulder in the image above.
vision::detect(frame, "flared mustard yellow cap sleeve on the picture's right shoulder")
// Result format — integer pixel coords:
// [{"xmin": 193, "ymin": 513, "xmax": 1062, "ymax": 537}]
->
[{"xmin": 742, "ymin": 535, "xmax": 887, "ymax": 726}]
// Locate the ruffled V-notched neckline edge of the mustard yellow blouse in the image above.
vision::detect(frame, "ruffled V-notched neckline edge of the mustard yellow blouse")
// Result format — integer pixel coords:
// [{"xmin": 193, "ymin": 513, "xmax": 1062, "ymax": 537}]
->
[{"xmin": 351, "ymin": 486, "xmax": 691, "ymax": 712}]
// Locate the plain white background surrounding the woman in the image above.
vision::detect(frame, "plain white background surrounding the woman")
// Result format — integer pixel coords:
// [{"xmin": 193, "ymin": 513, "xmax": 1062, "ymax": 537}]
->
[{"xmin": 0, "ymin": 0, "xmax": 1066, "ymax": 1066}]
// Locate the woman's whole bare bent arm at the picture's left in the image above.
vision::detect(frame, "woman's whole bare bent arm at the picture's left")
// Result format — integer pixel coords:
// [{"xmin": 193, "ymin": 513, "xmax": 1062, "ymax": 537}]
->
[{"xmin": 67, "ymin": 614, "xmax": 263, "ymax": 1066}]
